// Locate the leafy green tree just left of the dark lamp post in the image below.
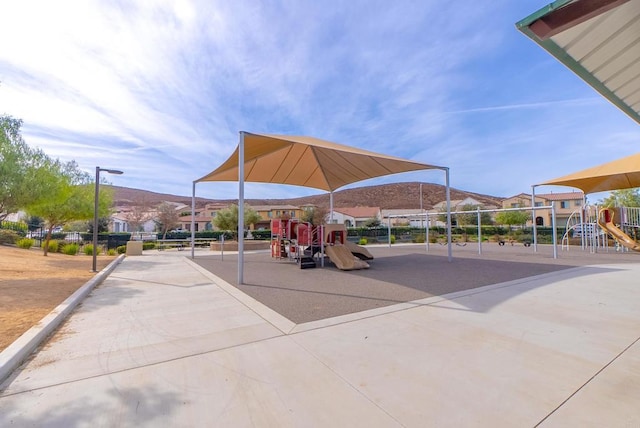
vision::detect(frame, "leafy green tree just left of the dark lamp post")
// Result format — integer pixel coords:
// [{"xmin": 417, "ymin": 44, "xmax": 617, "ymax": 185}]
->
[{"xmin": 25, "ymin": 159, "xmax": 113, "ymax": 256}]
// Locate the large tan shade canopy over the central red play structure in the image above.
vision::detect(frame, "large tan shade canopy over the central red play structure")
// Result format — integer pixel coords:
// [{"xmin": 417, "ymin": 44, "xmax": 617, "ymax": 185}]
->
[{"xmin": 196, "ymin": 132, "xmax": 446, "ymax": 192}]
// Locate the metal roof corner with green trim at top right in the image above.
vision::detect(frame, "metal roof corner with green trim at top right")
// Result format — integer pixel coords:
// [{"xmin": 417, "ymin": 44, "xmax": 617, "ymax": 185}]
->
[{"xmin": 516, "ymin": 0, "xmax": 640, "ymax": 123}]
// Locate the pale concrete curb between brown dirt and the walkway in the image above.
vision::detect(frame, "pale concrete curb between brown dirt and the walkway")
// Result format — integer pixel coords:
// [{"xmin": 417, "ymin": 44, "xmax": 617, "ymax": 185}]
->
[{"xmin": 0, "ymin": 254, "xmax": 125, "ymax": 384}]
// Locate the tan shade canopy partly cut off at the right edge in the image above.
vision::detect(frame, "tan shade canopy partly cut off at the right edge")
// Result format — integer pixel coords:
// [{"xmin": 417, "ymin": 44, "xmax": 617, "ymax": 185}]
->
[{"xmin": 541, "ymin": 153, "xmax": 640, "ymax": 193}]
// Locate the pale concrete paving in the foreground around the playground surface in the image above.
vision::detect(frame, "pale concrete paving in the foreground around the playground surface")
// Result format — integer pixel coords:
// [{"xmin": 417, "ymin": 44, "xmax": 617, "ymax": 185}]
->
[{"xmin": 0, "ymin": 253, "xmax": 640, "ymax": 427}]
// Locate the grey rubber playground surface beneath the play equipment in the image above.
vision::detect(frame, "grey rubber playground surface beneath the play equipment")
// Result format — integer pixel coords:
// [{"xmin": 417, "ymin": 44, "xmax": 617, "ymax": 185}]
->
[{"xmin": 194, "ymin": 243, "xmax": 640, "ymax": 324}]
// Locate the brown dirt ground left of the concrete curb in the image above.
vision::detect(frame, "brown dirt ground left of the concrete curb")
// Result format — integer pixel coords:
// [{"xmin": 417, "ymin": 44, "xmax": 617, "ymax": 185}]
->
[{"xmin": 0, "ymin": 245, "xmax": 115, "ymax": 351}]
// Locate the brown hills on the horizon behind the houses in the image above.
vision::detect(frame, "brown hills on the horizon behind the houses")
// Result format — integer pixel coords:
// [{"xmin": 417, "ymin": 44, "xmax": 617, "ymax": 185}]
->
[{"xmin": 110, "ymin": 182, "xmax": 504, "ymax": 209}]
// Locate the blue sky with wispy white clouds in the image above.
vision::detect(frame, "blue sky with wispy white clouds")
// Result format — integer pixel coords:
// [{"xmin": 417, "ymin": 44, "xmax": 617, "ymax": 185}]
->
[{"xmin": 0, "ymin": 0, "xmax": 640, "ymax": 199}]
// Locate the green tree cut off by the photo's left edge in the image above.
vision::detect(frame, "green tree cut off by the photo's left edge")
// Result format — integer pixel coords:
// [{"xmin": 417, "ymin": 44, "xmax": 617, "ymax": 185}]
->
[{"xmin": 0, "ymin": 116, "xmax": 48, "ymax": 220}]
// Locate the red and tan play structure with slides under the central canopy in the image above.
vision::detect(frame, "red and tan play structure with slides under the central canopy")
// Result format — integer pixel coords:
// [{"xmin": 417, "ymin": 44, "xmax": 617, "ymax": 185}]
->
[{"xmin": 271, "ymin": 219, "xmax": 373, "ymax": 270}]
